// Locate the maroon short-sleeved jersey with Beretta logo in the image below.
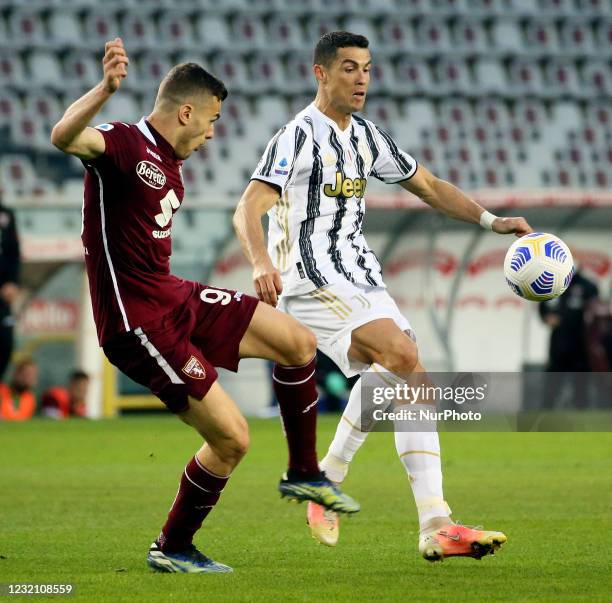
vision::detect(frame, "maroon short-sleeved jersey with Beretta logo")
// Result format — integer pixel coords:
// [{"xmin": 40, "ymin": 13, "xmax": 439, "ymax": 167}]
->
[{"xmin": 81, "ymin": 118, "xmax": 195, "ymax": 345}]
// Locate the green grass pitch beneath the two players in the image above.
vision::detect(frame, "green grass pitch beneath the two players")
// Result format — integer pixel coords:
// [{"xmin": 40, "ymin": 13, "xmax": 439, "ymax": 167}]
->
[{"xmin": 0, "ymin": 416, "xmax": 612, "ymax": 602}]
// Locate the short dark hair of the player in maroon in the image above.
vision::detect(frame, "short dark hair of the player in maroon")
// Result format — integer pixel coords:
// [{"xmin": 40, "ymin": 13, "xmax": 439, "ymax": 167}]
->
[{"xmin": 157, "ymin": 63, "xmax": 227, "ymax": 104}]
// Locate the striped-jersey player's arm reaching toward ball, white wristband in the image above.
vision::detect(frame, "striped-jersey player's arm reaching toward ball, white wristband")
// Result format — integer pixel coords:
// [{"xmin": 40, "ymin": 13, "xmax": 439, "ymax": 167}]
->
[{"xmin": 400, "ymin": 165, "xmax": 533, "ymax": 237}]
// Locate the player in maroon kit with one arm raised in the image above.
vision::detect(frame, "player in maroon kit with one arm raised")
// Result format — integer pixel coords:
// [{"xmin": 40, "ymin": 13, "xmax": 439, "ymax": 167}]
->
[{"xmin": 51, "ymin": 38, "xmax": 359, "ymax": 573}]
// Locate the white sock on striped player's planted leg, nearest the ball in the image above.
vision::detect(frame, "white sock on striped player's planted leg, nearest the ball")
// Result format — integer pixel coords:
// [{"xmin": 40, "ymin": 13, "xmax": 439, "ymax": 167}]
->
[{"xmin": 395, "ymin": 404, "xmax": 451, "ymax": 531}]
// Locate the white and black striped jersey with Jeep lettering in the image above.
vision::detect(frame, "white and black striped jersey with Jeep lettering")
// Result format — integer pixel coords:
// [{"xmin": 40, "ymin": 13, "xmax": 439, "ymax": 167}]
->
[{"xmin": 252, "ymin": 103, "xmax": 417, "ymax": 295}]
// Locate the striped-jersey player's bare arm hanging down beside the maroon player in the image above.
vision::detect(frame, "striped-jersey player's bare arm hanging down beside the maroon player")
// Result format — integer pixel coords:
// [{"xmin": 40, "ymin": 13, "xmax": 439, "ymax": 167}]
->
[{"xmin": 233, "ymin": 180, "xmax": 283, "ymax": 306}]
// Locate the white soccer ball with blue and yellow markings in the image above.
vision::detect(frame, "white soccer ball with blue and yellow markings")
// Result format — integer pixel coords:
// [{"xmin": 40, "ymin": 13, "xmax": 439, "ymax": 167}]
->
[{"xmin": 504, "ymin": 232, "xmax": 574, "ymax": 301}]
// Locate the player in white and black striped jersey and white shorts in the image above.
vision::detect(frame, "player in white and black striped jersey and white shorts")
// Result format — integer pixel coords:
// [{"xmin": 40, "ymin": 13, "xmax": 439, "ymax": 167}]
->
[{"xmin": 234, "ymin": 32, "xmax": 531, "ymax": 561}]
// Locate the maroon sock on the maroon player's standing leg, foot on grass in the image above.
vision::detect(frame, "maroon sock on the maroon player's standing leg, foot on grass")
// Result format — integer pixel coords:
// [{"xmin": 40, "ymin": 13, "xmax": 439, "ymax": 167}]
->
[{"xmin": 157, "ymin": 456, "xmax": 229, "ymax": 552}]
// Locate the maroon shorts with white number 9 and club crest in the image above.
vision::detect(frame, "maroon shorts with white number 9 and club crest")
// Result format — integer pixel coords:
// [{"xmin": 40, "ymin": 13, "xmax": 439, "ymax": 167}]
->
[{"xmin": 103, "ymin": 283, "xmax": 258, "ymax": 413}]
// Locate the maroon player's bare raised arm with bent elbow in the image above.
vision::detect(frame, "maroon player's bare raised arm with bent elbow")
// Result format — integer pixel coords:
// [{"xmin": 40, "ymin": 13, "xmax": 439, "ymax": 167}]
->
[{"xmin": 51, "ymin": 38, "xmax": 129, "ymax": 159}]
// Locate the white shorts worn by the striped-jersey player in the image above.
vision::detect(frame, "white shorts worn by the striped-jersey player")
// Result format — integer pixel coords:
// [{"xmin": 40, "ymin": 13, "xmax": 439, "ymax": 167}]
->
[{"xmin": 278, "ymin": 281, "xmax": 414, "ymax": 377}]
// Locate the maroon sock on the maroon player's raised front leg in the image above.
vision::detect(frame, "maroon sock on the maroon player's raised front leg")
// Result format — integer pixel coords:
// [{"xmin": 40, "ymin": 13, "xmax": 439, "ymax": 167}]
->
[{"xmin": 272, "ymin": 358, "xmax": 320, "ymax": 479}]
